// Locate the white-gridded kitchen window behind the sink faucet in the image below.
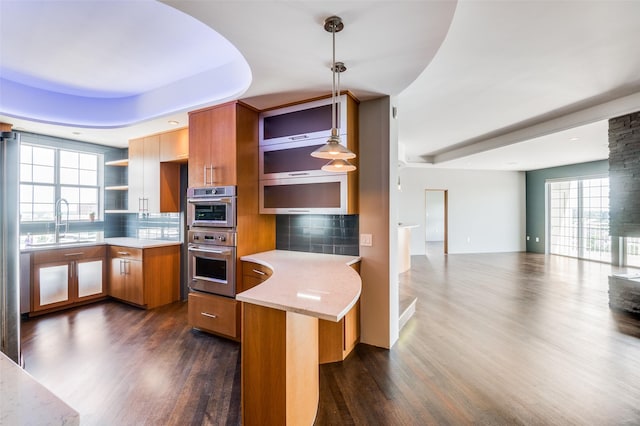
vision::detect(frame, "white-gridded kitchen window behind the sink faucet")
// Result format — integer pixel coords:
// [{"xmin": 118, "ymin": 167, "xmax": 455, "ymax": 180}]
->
[{"xmin": 20, "ymin": 143, "xmax": 101, "ymax": 223}]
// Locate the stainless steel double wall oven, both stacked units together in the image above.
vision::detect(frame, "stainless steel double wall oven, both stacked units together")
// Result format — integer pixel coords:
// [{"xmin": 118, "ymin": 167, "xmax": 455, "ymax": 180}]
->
[{"xmin": 187, "ymin": 186, "xmax": 237, "ymax": 297}]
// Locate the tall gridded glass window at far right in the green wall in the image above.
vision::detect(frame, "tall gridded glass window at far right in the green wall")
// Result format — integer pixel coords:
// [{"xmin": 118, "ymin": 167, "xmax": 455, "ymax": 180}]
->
[{"xmin": 547, "ymin": 178, "xmax": 611, "ymax": 262}]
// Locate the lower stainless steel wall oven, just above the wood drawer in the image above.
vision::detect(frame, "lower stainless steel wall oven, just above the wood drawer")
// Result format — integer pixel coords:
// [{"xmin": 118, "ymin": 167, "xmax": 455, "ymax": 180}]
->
[{"xmin": 188, "ymin": 228, "xmax": 236, "ymax": 297}]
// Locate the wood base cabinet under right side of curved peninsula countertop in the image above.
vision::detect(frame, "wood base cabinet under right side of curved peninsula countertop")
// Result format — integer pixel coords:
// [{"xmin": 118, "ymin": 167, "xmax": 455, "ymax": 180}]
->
[{"xmin": 318, "ymin": 262, "xmax": 360, "ymax": 364}]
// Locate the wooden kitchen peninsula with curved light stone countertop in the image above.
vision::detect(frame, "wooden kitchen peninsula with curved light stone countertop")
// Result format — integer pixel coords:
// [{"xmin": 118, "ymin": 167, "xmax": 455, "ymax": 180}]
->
[{"xmin": 236, "ymin": 250, "xmax": 362, "ymax": 425}]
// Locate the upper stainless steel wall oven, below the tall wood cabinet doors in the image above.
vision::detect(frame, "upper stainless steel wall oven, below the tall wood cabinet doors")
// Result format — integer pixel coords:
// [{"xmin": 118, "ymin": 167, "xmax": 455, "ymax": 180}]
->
[{"xmin": 187, "ymin": 186, "xmax": 236, "ymax": 228}]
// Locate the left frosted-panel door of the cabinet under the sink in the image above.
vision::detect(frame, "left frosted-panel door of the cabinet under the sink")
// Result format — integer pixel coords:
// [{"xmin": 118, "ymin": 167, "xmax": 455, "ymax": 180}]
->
[{"xmin": 32, "ymin": 262, "xmax": 71, "ymax": 311}]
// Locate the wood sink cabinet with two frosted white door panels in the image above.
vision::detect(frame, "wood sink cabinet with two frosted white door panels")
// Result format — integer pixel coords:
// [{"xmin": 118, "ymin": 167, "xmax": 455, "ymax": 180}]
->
[{"xmin": 31, "ymin": 246, "xmax": 106, "ymax": 315}]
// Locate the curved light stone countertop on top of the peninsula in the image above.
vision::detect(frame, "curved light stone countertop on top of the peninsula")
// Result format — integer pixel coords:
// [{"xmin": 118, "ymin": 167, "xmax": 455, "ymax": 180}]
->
[{"xmin": 236, "ymin": 250, "xmax": 362, "ymax": 322}]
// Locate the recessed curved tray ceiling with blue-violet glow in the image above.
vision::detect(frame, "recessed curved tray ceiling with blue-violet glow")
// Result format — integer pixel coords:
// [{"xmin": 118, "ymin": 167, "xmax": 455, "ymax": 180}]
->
[{"xmin": 0, "ymin": 0, "xmax": 252, "ymax": 128}]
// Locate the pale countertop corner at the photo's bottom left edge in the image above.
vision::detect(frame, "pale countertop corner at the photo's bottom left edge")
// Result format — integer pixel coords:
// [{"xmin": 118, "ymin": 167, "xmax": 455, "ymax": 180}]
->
[{"xmin": 0, "ymin": 352, "xmax": 80, "ymax": 425}]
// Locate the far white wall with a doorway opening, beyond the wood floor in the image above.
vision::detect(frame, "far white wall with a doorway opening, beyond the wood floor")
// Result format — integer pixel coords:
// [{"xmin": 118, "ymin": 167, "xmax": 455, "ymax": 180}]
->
[{"xmin": 399, "ymin": 168, "xmax": 526, "ymax": 255}]
